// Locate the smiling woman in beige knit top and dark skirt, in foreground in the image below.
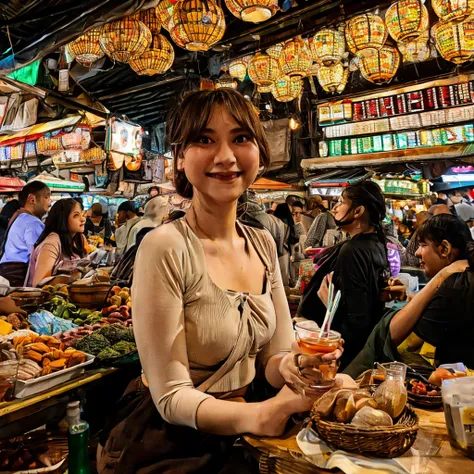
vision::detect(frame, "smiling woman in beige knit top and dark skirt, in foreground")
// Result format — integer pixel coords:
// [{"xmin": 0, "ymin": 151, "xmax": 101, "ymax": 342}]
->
[{"xmin": 98, "ymin": 89, "xmax": 339, "ymax": 473}]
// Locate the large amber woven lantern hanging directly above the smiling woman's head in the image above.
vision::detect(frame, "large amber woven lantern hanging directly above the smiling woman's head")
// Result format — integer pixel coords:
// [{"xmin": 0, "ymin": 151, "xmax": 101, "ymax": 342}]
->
[{"xmin": 173, "ymin": 0, "xmax": 225, "ymax": 51}]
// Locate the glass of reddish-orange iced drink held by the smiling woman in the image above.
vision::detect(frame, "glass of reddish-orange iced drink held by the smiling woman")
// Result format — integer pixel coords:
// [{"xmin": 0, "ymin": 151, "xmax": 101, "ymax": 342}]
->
[{"xmin": 295, "ymin": 321, "xmax": 341, "ymax": 390}]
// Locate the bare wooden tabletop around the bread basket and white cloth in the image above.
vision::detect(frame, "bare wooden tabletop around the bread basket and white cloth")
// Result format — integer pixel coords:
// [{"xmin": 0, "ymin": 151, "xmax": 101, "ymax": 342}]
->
[{"xmin": 244, "ymin": 409, "xmax": 474, "ymax": 474}]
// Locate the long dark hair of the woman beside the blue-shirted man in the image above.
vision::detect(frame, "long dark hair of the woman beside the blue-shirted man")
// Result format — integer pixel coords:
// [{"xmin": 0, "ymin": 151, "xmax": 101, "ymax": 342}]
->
[{"xmin": 35, "ymin": 198, "xmax": 86, "ymax": 258}]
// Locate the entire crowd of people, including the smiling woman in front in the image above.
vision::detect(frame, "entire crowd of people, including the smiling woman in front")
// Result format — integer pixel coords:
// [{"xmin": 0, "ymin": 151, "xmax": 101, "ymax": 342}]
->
[{"xmin": 0, "ymin": 89, "xmax": 474, "ymax": 473}]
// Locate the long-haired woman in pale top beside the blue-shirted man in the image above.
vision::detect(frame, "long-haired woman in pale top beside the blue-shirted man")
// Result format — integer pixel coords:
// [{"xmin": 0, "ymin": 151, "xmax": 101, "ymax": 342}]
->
[{"xmin": 26, "ymin": 199, "xmax": 86, "ymax": 287}]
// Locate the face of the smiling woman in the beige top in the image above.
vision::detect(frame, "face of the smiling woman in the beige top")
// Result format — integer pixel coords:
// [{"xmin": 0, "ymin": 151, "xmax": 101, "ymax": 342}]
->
[{"xmin": 178, "ymin": 107, "xmax": 260, "ymax": 203}]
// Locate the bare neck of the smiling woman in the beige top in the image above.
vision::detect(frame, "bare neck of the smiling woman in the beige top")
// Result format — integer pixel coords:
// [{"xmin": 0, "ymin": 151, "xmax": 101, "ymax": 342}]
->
[{"xmin": 191, "ymin": 196, "xmax": 237, "ymax": 240}]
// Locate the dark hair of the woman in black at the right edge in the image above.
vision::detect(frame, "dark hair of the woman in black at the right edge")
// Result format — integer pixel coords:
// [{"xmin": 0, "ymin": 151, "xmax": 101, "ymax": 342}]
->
[{"xmin": 417, "ymin": 214, "xmax": 474, "ymax": 270}]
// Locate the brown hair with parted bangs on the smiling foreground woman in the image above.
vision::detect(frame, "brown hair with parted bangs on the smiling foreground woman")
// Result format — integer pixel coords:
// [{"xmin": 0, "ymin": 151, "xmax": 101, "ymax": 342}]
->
[{"xmin": 167, "ymin": 88, "xmax": 270, "ymax": 199}]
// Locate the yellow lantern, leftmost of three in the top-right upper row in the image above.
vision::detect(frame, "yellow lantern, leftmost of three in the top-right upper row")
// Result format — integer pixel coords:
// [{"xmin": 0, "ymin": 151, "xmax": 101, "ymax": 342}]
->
[{"xmin": 346, "ymin": 13, "xmax": 387, "ymax": 54}]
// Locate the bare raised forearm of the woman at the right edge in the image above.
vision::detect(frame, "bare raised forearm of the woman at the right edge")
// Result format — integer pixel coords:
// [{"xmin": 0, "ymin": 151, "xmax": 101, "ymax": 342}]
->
[{"xmin": 390, "ymin": 260, "xmax": 469, "ymax": 345}]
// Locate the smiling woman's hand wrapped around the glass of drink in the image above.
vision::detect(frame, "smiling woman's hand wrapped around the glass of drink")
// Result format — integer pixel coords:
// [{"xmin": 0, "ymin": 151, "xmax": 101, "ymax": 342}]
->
[{"xmin": 280, "ymin": 339, "xmax": 344, "ymax": 398}]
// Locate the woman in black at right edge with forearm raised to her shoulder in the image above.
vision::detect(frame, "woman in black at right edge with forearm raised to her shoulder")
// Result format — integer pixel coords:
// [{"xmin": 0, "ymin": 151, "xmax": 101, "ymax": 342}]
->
[{"xmin": 345, "ymin": 214, "xmax": 474, "ymax": 377}]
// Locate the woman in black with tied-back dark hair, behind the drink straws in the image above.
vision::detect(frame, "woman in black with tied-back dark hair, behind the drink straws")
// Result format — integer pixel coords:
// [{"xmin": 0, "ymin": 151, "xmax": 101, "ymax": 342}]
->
[{"xmin": 298, "ymin": 181, "xmax": 389, "ymax": 367}]
